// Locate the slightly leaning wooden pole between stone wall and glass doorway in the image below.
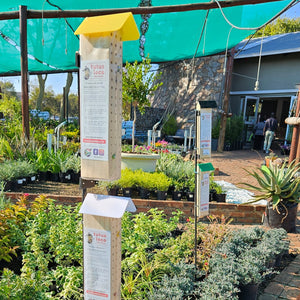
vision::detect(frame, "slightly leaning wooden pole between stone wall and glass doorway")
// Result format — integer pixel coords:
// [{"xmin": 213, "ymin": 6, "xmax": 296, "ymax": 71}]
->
[{"xmin": 217, "ymin": 48, "xmax": 235, "ymax": 152}]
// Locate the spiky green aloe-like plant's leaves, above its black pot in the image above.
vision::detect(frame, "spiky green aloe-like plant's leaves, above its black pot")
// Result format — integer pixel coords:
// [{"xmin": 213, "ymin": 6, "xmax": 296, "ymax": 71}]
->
[{"xmin": 242, "ymin": 162, "xmax": 300, "ymax": 209}]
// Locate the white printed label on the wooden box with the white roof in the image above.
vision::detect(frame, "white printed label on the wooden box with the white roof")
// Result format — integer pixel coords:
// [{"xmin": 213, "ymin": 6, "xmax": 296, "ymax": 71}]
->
[{"xmin": 83, "ymin": 228, "xmax": 111, "ymax": 300}]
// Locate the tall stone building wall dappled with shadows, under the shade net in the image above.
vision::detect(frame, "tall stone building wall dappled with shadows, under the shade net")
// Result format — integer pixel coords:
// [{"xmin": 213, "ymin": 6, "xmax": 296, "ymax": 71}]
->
[{"xmin": 151, "ymin": 55, "xmax": 224, "ymax": 128}]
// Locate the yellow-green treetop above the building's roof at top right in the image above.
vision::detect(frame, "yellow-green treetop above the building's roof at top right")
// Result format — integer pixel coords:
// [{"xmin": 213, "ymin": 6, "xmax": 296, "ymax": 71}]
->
[{"xmin": 253, "ymin": 18, "xmax": 300, "ymax": 37}]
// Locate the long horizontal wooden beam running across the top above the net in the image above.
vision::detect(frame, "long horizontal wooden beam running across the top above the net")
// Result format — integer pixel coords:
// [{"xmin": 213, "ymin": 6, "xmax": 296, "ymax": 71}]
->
[{"xmin": 0, "ymin": 0, "xmax": 286, "ymax": 20}]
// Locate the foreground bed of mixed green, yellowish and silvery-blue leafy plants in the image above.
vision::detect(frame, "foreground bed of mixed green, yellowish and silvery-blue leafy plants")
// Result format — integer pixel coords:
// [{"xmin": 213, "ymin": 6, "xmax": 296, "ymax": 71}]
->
[{"xmin": 0, "ymin": 195, "xmax": 288, "ymax": 299}]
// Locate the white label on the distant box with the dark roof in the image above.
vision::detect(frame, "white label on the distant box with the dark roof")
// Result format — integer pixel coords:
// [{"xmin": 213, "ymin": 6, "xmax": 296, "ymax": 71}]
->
[{"xmin": 200, "ymin": 109, "xmax": 212, "ymax": 157}]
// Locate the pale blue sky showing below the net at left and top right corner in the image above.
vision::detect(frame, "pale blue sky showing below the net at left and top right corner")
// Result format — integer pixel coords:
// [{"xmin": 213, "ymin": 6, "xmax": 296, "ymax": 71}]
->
[{"xmin": 0, "ymin": 3, "xmax": 300, "ymax": 94}]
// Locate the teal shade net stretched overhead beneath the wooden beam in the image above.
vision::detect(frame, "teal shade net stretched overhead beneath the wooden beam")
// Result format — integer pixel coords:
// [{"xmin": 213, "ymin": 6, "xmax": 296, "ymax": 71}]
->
[{"xmin": 0, "ymin": 0, "xmax": 291, "ymax": 74}]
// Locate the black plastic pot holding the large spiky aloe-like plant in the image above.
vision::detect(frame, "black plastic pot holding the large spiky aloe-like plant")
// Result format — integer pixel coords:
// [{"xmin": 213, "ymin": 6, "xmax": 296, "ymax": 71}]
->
[{"xmin": 263, "ymin": 202, "xmax": 298, "ymax": 232}]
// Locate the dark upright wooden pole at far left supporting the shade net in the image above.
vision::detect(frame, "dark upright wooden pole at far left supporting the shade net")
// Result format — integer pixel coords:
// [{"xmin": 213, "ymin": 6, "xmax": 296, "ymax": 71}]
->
[{"xmin": 20, "ymin": 5, "xmax": 30, "ymax": 139}]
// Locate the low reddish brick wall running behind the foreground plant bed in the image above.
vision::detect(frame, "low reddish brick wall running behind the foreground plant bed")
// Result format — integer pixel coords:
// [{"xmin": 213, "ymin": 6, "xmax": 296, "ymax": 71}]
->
[{"xmin": 6, "ymin": 193, "xmax": 265, "ymax": 225}]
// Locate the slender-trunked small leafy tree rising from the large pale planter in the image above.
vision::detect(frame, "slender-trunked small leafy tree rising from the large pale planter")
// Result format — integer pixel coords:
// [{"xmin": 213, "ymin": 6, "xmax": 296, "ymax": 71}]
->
[{"xmin": 122, "ymin": 56, "xmax": 162, "ymax": 151}]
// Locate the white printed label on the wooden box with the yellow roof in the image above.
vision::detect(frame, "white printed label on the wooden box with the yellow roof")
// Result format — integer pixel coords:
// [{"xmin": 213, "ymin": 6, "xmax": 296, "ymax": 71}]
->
[{"xmin": 80, "ymin": 60, "xmax": 109, "ymax": 161}]
